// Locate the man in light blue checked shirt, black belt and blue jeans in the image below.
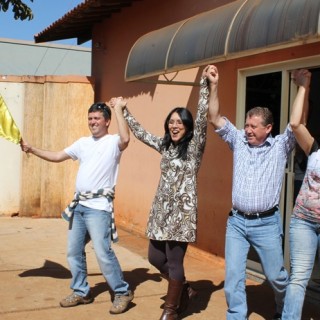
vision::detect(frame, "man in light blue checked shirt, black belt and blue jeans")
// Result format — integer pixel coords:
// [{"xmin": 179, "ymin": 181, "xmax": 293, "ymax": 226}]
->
[{"xmin": 206, "ymin": 66, "xmax": 295, "ymax": 320}]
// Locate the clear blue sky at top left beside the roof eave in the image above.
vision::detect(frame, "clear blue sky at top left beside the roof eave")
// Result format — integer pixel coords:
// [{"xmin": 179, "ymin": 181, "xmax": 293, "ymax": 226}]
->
[{"xmin": 0, "ymin": 0, "xmax": 91, "ymax": 48}]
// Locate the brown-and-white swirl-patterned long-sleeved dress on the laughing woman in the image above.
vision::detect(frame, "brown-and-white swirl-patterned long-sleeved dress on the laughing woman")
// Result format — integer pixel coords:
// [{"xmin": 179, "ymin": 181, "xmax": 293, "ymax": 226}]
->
[{"xmin": 124, "ymin": 78, "xmax": 209, "ymax": 242}]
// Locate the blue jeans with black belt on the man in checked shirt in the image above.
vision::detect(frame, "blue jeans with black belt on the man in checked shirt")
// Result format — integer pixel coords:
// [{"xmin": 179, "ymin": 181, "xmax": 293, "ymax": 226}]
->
[{"xmin": 224, "ymin": 210, "xmax": 289, "ymax": 320}]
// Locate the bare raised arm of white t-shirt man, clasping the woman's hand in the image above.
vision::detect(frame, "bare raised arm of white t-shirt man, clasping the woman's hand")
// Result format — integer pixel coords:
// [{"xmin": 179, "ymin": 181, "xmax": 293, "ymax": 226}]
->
[{"xmin": 110, "ymin": 97, "xmax": 130, "ymax": 151}]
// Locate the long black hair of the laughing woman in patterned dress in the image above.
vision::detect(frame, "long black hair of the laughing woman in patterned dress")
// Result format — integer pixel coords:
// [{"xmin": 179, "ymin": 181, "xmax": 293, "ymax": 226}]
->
[{"xmin": 162, "ymin": 107, "xmax": 193, "ymax": 160}]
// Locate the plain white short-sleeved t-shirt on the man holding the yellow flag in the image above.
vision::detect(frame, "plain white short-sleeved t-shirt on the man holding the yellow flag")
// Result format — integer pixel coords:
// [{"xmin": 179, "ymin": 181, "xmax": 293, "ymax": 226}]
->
[{"xmin": 64, "ymin": 134, "xmax": 121, "ymax": 211}]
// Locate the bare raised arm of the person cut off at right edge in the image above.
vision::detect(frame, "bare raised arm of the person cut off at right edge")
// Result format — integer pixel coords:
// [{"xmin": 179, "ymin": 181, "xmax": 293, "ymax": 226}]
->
[{"xmin": 290, "ymin": 69, "xmax": 314, "ymax": 155}]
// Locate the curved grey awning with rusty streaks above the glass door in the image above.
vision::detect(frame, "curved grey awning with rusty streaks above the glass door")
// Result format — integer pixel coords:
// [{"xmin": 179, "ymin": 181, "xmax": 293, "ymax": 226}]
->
[{"xmin": 125, "ymin": 0, "xmax": 320, "ymax": 81}]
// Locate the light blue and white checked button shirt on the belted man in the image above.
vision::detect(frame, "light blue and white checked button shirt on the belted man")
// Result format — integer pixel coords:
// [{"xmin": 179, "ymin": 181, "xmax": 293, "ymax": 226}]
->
[{"xmin": 216, "ymin": 119, "xmax": 296, "ymax": 212}]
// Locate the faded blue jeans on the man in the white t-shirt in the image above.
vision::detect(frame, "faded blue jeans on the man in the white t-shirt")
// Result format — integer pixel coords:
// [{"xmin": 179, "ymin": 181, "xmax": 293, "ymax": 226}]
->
[{"xmin": 67, "ymin": 204, "xmax": 129, "ymax": 296}]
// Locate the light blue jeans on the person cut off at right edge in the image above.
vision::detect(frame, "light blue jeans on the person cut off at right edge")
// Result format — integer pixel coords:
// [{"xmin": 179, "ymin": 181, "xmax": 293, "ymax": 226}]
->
[{"xmin": 282, "ymin": 218, "xmax": 320, "ymax": 320}]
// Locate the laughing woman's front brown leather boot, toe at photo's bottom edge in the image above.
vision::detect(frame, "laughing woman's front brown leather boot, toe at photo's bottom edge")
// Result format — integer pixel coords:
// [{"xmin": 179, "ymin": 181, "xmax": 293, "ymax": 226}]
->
[{"xmin": 160, "ymin": 278, "xmax": 183, "ymax": 320}]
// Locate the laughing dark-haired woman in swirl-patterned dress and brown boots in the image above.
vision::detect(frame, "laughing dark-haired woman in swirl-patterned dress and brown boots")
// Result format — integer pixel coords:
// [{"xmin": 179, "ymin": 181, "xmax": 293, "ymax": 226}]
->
[{"xmin": 110, "ymin": 68, "xmax": 208, "ymax": 320}]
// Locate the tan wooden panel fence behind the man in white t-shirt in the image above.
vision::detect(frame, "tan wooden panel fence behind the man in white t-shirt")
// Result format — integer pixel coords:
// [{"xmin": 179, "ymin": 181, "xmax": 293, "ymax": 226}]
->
[{"xmin": 0, "ymin": 76, "xmax": 94, "ymax": 218}]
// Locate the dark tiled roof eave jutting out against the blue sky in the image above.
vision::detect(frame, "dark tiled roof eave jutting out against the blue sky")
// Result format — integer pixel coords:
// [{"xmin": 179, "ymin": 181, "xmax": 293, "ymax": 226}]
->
[{"xmin": 34, "ymin": 0, "xmax": 140, "ymax": 44}]
